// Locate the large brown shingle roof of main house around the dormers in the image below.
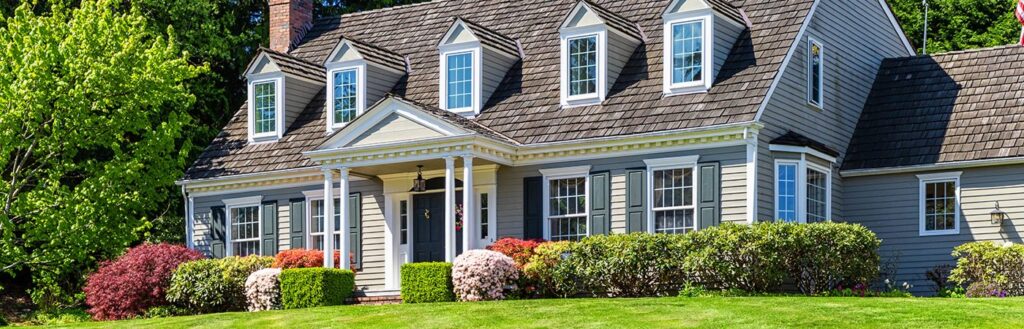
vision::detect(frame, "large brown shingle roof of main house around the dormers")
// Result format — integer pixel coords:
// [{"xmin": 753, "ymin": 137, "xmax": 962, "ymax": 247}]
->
[{"xmin": 185, "ymin": 0, "xmax": 813, "ymax": 179}]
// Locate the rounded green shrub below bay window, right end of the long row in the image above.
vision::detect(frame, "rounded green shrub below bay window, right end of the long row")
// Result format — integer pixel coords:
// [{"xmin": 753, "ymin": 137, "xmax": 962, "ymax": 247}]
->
[{"xmin": 790, "ymin": 222, "xmax": 882, "ymax": 294}]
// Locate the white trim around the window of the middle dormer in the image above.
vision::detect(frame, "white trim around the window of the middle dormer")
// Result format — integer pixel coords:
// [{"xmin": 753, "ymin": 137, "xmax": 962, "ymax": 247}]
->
[{"xmin": 437, "ymin": 41, "xmax": 483, "ymax": 117}]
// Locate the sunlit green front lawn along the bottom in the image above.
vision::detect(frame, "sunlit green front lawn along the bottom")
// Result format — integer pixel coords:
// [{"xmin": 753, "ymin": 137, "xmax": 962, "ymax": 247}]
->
[{"xmin": 49, "ymin": 297, "xmax": 1024, "ymax": 329}]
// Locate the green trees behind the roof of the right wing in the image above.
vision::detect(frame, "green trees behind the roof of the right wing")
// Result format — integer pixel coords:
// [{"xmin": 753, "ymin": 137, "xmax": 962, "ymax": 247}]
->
[{"xmin": 889, "ymin": 0, "xmax": 1021, "ymax": 53}]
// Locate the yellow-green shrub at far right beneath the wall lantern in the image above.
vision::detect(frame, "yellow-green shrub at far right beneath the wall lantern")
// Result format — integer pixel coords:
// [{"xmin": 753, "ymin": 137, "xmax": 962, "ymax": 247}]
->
[{"xmin": 949, "ymin": 242, "xmax": 1024, "ymax": 297}]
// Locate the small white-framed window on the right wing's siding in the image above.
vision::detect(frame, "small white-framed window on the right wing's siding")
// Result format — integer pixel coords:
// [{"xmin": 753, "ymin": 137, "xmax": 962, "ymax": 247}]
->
[{"xmin": 918, "ymin": 171, "xmax": 962, "ymax": 236}]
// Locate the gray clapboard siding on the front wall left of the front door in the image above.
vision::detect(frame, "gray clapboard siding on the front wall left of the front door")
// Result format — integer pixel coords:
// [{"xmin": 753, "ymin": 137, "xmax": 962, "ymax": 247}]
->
[{"xmin": 195, "ymin": 180, "xmax": 385, "ymax": 290}]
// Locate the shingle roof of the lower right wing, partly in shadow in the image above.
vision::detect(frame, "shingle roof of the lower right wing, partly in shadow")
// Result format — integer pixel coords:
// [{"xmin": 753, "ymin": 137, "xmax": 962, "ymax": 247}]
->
[{"xmin": 843, "ymin": 45, "xmax": 1024, "ymax": 170}]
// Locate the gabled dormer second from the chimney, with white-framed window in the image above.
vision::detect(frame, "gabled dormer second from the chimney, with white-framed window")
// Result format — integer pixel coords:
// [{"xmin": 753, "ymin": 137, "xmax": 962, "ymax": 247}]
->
[{"xmin": 324, "ymin": 37, "xmax": 409, "ymax": 132}]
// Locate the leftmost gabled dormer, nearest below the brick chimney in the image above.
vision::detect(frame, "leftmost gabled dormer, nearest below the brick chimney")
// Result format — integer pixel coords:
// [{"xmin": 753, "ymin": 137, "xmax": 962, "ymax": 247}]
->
[{"xmin": 246, "ymin": 48, "xmax": 324, "ymax": 142}]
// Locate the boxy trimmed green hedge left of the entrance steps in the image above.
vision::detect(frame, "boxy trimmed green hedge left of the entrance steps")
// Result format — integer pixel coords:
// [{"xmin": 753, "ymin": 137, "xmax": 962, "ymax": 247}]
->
[{"xmin": 280, "ymin": 268, "xmax": 355, "ymax": 310}]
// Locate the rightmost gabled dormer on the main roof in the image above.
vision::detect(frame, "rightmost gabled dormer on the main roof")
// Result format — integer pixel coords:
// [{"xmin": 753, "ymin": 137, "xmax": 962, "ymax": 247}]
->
[{"xmin": 662, "ymin": 0, "xmax": 749, "ymax": 95}]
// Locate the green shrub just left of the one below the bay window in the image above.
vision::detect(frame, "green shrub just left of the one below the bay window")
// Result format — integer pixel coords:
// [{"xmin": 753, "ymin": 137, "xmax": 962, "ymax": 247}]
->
[{"xmin": 679, "ymin": 222, "xmax": 798, "ymax": 292}]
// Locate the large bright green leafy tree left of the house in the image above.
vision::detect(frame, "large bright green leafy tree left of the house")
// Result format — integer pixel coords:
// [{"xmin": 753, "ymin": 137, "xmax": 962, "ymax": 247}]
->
[{"xmin": 0, "ymin": 0, "xmax": 205, "ymax": 306}]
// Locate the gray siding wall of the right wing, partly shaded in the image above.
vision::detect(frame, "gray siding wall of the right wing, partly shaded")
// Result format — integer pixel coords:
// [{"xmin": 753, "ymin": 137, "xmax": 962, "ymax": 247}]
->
[{"xmin": 845, "ymin": 165, "xmax": 1024, "ymax": 294}]
